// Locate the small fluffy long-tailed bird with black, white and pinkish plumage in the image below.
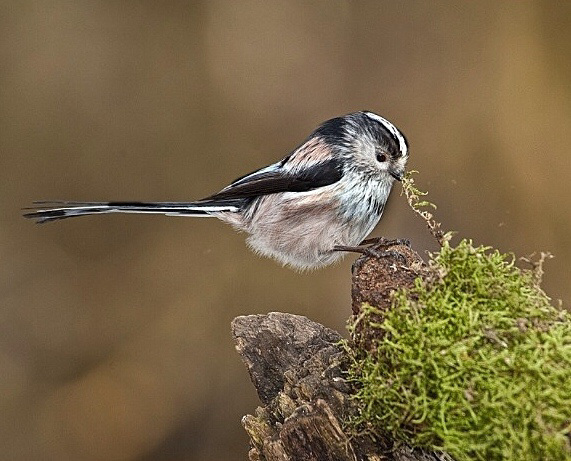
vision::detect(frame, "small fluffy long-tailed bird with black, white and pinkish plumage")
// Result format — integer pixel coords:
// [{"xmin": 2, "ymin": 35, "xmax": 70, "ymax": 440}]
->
[{"xmin": 24, "ymin": 111, "xmax": 409, "ymax": 271}]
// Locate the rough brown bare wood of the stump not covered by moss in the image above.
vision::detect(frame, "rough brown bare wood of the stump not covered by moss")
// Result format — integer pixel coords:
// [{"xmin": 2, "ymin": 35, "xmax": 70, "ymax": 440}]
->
[{"xmin": 232, "ymin": 245, "xmax": 451, "ymax": 461}]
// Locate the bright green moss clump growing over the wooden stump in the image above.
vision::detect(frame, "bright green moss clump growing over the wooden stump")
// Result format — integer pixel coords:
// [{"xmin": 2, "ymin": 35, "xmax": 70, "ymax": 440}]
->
[{"xmin": 350, "ymin": 241, "xmax": 571, "ymax": 461}]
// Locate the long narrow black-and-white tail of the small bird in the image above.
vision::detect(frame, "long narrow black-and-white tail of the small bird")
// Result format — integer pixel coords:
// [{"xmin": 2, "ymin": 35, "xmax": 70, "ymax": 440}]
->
[{"xmin": 24, "ymin": 200, "xmax": 242, "ymax": 223}]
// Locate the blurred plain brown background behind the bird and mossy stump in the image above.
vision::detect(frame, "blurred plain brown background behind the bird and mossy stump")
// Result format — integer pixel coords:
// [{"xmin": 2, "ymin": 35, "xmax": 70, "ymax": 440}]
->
[{"xmin": 0, "ymin": 0, "xmax": 571, "ymax": 461}]
